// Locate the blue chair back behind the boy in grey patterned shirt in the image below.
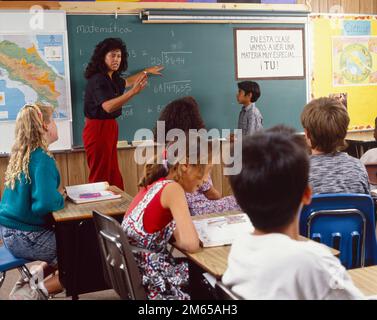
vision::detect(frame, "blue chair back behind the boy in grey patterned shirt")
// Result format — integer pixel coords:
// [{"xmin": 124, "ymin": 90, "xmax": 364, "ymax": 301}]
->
[{"xmin": 300, "ymin": 193, "xmax": 377, "ymax": 269}]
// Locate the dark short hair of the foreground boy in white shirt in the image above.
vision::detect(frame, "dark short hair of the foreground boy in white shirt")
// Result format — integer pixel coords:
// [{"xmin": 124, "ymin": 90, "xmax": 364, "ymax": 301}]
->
[{"xmin": 230, "ymin": 131, "xmax": 309, "ymax": 232}]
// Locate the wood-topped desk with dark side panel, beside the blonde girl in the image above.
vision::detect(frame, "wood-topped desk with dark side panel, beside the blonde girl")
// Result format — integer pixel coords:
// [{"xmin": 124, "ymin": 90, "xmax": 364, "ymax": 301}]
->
[{"xmin": 53, "ymin": 187, "xmax": 132, "ymax": 299}]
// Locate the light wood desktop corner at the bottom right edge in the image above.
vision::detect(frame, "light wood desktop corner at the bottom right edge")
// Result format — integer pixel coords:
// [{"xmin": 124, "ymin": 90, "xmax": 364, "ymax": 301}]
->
[{"xmin": 348, "ymin": 266, "xmax": 377, "ymax": 296}]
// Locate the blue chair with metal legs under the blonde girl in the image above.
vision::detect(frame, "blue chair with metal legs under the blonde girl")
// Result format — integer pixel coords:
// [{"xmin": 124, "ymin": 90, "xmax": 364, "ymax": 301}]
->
[{"xmin": 0, "ymin": 244, "xmax": 48, "ymax": 300}]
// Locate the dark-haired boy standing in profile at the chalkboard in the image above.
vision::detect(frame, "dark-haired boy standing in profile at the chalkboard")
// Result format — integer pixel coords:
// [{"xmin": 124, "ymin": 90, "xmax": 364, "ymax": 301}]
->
[{"xmin": 237, "ymin": 81, "xmax": 263, "ymax": 136}]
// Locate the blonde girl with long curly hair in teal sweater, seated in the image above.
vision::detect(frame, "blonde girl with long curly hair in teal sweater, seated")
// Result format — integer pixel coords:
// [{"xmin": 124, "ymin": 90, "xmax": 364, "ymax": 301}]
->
[{"xmin": 0, "ymin": 104, "xmax": 64, "ymax": 299}]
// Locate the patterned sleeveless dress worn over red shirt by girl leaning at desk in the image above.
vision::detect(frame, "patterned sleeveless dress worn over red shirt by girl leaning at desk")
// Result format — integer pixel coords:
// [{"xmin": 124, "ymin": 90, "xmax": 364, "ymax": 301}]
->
[{"xmin": 122, "ymin": 180, "xmax": 190, "ymax": 300}]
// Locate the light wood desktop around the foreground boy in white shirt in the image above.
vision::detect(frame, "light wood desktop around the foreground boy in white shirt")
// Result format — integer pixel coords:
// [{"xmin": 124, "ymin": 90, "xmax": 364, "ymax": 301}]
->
[{"xmin": 184, "ymin": 211, "xmax": 340, "ymax": 279}]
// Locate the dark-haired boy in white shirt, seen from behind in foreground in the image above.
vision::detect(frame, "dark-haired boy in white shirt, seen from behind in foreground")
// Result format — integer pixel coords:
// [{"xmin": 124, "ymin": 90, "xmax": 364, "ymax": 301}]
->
[{"xmin": 222, "ymin": 127, "xmax": 364, "ymax": 300}]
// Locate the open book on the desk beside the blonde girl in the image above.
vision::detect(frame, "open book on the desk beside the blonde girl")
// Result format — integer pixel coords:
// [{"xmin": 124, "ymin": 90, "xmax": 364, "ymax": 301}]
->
[{"xmin": 65, "ymin": 182, "xmax": 122, "ymax": 203}]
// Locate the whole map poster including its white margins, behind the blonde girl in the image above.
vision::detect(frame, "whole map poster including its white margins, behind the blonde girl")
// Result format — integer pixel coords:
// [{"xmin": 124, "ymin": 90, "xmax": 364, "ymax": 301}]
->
[{"xmin": 0, "ymin": 7, "xmax": 72, "ymax": 155}]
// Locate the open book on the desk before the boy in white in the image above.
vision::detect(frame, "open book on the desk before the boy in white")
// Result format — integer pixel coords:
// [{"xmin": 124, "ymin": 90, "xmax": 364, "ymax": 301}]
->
[{"xmin": 193, "ymin": 213, "xmax": 254, "ymax": 247}]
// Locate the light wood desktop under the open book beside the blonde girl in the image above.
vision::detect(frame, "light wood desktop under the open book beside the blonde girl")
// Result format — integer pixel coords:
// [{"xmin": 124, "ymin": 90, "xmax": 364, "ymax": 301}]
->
[{"xmin": 52, "ymin": 186, "xmax": 133, "ymax": 222}]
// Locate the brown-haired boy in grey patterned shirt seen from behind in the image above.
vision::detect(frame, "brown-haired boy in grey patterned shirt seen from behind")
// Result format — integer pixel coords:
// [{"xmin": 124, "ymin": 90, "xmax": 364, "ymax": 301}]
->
[{"xmin": 301, "ymin": 98, "xmax": 369, "ymax": 194}]
